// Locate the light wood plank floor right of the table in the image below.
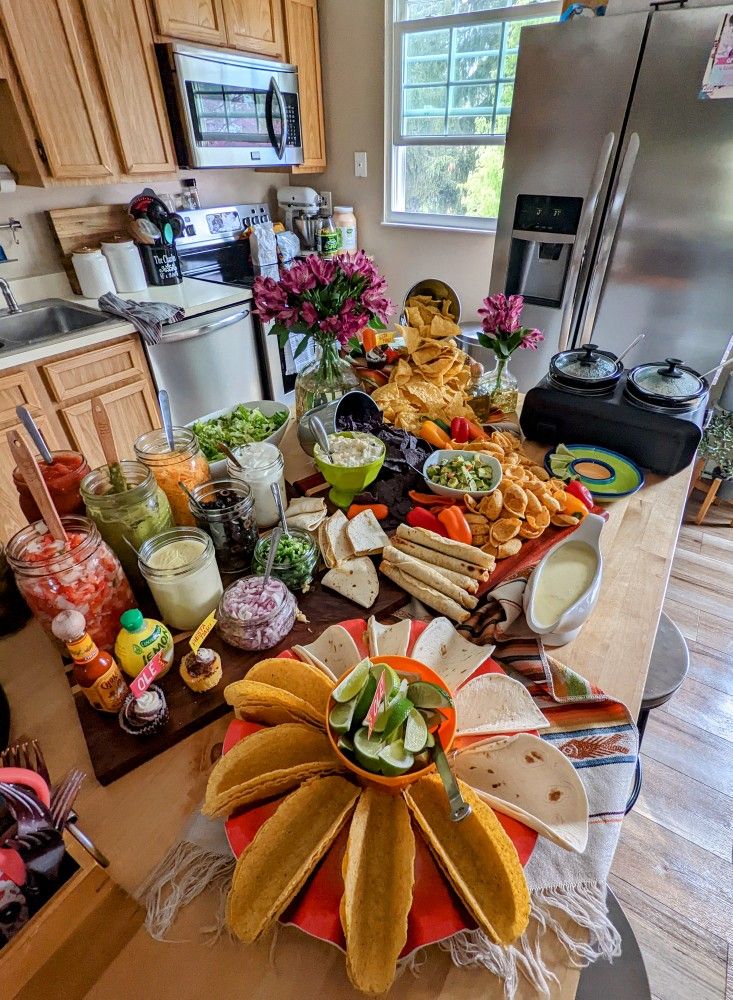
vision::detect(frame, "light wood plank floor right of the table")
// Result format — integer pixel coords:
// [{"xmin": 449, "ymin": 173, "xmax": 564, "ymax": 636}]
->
[{"xmin": 610, "ymin": 494, "xmax": 733, "ymax": 1000}]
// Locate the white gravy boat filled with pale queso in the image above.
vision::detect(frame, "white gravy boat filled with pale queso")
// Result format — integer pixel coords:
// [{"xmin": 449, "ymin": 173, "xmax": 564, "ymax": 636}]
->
[{"xmin": 524, "ymin": 514, "xmax": 604, "ymax": 646}]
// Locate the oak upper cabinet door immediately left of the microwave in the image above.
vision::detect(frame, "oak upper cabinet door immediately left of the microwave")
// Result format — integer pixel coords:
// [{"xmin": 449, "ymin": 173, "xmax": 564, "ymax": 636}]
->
[{"xmin": 82, "ymin": 0, "xmax": 176, "ymax": 174}]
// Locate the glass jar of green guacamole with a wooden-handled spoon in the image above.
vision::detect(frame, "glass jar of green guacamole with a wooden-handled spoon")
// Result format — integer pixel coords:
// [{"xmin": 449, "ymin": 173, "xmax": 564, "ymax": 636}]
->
[{"xmin": 80, "ymin": 462, "xmax": 173, "ymax": 586}]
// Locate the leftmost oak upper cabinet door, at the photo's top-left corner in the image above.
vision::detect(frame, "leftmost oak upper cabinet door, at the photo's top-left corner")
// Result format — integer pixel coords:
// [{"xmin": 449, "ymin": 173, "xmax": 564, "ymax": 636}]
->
[{"xmin": 0, "ymin": 0, "xmax": 114, "ymax": 180}]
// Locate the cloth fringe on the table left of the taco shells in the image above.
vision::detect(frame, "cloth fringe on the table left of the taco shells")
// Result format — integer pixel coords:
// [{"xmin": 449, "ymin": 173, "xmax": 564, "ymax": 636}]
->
[{"xmin": 135, "ymin": 841, "xmax": 236, "ymax": 945}]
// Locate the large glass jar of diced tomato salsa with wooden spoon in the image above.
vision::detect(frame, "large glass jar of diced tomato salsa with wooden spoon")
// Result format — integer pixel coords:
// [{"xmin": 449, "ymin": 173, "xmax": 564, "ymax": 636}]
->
[{"xmin": 6, "ymin": 517, "xmax": 136, "ymax": 650}]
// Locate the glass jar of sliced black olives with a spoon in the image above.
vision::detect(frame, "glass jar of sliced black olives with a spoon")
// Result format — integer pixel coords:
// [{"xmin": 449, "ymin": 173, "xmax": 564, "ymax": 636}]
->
[{"xmin": 189, "ymin": 479, "xmax": 257, "ymax": 573}]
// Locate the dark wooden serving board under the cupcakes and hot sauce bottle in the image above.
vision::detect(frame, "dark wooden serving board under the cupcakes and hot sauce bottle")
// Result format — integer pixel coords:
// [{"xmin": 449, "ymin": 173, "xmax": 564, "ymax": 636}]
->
[{"xmin": 69, "ymin": 576, "xmax": 410, "ymax": 785}]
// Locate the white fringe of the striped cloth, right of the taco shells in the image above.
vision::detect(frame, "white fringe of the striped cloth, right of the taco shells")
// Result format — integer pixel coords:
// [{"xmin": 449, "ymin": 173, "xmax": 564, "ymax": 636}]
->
[{"xmin": 440, "ymin": 882, "xmax": 621, "ymax": 1000}]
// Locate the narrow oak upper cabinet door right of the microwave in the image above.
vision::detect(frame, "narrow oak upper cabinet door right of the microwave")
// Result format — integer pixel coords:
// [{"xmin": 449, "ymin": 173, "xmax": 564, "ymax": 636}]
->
[{"xmin": 285, "ymin": 0, "xmax": 326, "ymax": 173}]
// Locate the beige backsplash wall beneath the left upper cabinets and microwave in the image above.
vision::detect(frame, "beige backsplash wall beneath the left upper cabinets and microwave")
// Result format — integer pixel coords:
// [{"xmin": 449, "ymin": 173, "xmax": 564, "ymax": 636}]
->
[{"xmin": 0, "ymin": 169, "xmax": 284, "ymax": 281}]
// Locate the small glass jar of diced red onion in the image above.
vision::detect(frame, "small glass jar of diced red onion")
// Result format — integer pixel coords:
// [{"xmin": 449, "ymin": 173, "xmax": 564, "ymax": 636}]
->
[{"xmin": 216, "ymin": 576, "xmax": 297, "ymax": 649}]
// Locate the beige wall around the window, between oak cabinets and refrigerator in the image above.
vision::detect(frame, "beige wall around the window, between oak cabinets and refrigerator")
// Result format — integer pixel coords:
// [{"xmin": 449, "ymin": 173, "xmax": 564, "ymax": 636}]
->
[{"xmin": 300, "ymin": 0, "xmax": 494, "ymax": 319}]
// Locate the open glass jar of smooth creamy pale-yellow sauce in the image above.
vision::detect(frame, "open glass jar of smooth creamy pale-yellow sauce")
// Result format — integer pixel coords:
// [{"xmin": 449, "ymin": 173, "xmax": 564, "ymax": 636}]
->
[{"xmin": 138, "ymin": 528, "xmax": 224, "ymax": 631}]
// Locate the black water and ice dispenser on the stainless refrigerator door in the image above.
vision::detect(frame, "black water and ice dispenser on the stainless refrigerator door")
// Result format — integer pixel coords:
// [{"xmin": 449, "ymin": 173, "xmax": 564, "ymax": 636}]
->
[{"xmin": 506, "ymin": 194, "xmax": 583, "ymax": 309}]
